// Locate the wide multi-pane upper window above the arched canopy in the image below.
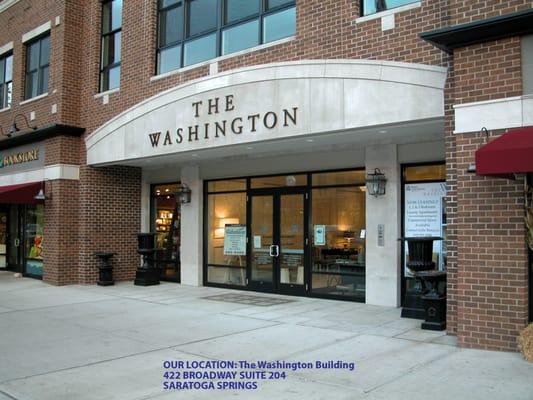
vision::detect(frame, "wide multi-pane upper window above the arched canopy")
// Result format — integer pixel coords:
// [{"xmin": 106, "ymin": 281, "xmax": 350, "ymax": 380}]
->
[{"xmin": 157, "ymin": 0, "xmax": 296, "ymax": 74}]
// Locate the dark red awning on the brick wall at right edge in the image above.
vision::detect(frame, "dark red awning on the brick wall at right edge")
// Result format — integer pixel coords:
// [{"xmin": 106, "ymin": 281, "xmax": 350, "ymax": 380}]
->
[{"xmin": 476, "ymin": 127, "xmax": 533, "ymax": 177}]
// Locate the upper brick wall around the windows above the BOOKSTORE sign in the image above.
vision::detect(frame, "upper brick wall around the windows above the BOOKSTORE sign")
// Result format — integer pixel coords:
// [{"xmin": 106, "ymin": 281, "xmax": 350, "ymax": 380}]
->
[{"xmin": 0, "ymin": 0, "xmax": 82, "ymax": 136}]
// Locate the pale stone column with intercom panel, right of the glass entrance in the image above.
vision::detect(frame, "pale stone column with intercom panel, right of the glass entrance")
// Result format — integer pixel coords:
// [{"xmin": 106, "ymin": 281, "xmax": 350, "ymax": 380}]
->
[{"xmin": 365, "ymin": 144, "xmax": 401, "ymax": 307}]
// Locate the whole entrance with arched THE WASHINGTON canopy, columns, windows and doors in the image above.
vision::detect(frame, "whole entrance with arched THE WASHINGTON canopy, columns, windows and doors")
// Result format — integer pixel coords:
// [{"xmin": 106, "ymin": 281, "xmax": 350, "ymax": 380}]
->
[{"xmin": 86, "ymin": 60, "xmax": 446, "ymax": 306}]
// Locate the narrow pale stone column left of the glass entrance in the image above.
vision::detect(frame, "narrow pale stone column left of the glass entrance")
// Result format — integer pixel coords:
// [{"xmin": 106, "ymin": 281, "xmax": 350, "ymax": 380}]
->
[{"xmin": 180, "ymin": 165, "xmax": 203, "ymax": 286}]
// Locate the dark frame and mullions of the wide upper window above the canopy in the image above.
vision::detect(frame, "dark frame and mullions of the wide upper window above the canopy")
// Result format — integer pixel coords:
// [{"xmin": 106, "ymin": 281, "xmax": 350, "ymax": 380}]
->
[{"xmin": 156, "ymin": 0, "xmax": 296, "ymax": 75}]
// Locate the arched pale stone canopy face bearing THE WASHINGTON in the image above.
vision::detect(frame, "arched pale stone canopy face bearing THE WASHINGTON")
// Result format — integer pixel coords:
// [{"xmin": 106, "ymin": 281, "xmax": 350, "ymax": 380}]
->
[{"xmin": 86, "ymin": 60, "xmax": 446, "ymax": 165}]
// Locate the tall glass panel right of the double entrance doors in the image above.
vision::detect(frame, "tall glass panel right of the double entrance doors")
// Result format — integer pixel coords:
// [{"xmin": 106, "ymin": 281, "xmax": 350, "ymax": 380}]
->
[{"xmin": 312, "ymin": 186, "xmax": 366, "ymax": 300}]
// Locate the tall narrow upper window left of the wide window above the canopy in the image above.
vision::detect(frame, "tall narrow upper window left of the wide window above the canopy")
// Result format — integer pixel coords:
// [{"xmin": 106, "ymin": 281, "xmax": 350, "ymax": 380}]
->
[{"xmin": 100, "ymin": 0, "xmax": 122, "ymax": 92}]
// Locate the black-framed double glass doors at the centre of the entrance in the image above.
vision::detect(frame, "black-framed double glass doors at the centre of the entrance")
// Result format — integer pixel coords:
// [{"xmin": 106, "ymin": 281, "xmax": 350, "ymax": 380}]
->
[{"xmin": 248, "ymin": 189, "xmax": 308, "ymax": 294}]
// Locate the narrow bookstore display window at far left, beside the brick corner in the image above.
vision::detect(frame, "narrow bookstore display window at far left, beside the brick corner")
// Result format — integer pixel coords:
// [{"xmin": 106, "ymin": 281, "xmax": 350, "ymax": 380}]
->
[{"xmin": 24, "ymin": 204, "xmax": 44, "ymax": 276}]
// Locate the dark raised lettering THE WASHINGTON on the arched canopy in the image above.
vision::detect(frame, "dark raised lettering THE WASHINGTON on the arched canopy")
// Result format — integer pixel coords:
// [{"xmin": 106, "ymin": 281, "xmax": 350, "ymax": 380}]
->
[{"xmin": 148, "ymin": 94, "xmax": 298, "ymax": 148}]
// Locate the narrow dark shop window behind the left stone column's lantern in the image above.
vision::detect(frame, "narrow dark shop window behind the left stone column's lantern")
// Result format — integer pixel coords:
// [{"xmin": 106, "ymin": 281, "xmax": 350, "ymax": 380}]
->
[{"xmin": 152, "ymin": 183, "xmax": 181, "ymax": 281}]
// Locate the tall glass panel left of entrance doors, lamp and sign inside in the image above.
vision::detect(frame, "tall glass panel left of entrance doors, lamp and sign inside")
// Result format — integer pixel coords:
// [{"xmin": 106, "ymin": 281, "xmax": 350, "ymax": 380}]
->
[{"xmin": 207, "ymin": 192, "xmax": 246, "ymax": 286}]
